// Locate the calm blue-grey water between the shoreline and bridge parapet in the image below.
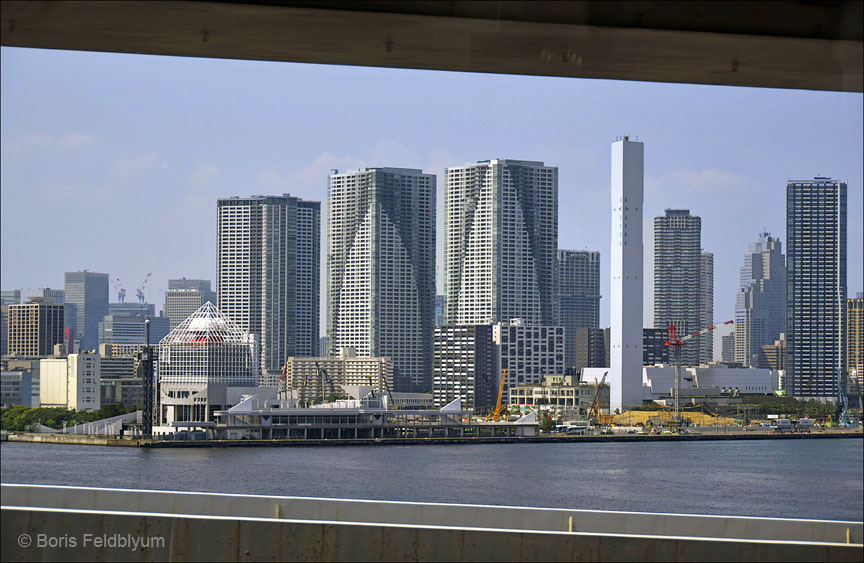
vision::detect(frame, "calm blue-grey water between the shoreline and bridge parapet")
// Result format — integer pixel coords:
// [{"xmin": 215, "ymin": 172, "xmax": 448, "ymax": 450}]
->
[{"xmin": 0, "ymin": 439, "xmax": 864, "ymax": 521}]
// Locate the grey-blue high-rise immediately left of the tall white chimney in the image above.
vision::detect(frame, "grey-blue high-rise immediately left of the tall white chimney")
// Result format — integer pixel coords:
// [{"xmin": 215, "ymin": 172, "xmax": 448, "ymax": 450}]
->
[{"xmin": 556, "ymin": 250, "xmax": 600, "ymax": 367}]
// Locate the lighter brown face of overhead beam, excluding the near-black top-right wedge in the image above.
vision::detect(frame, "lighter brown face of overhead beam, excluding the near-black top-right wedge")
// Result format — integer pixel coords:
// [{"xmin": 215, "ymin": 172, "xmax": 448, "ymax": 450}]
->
[{"xmin": 0, "ymin": 1, "xmax": 864, "ymax": 92}]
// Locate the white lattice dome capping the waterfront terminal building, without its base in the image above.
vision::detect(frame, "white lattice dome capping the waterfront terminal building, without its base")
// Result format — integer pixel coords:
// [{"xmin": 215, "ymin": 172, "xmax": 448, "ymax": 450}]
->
[{"xmin": 159, "ymin": 301, "xmax": 258, "ymax": 385}]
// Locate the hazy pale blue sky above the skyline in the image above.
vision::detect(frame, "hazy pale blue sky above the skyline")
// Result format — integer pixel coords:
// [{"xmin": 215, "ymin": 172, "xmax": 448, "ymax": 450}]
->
[{"xmin": 0, "ymin": 48, "xmax": 864, "ymax": 353}]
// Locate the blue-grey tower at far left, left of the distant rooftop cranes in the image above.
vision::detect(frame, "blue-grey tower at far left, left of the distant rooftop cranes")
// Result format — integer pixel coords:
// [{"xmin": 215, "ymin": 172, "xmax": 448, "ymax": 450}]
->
[{"xmin": 64, "ymin": 270, "xmax": 108, "ymax": 350}]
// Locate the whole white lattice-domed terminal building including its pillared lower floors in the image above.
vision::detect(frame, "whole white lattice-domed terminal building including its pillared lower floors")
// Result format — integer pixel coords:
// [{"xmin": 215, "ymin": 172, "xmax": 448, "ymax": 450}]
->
[{"xmin": 154, "ymin": 301, "xmax": 259, "ymax": 433}]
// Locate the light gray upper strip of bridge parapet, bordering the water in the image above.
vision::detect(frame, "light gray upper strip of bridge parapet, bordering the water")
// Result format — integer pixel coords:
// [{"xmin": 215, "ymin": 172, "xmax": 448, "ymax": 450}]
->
[{"xmin": 0, "ymin": 484, "xmax": 864, "ymax": 544}]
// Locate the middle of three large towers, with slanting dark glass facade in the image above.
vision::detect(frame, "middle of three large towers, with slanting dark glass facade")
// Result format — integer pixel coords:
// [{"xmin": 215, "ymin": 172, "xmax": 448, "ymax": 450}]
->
[{"xmin": 327, "ymin": 168, "xmax": 435, "ymax": 392}]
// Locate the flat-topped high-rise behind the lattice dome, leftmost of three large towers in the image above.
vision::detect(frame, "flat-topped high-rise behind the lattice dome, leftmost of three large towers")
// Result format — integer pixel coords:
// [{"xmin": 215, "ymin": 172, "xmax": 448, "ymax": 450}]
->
[{"xmin": 219, "ymin": 194, "xmax": 321, "ymax": 376}]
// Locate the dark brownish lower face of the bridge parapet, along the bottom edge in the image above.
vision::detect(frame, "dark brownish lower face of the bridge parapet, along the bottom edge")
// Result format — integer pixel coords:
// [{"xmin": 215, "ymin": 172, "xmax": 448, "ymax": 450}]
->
[{"xmin": 0, "ymin": 508, "xmax": 862, "ymax": 562}]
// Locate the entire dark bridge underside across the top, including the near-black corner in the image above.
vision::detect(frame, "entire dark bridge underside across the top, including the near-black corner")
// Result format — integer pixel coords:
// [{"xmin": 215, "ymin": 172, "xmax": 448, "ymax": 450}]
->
[{"xmin": 0, "ymin": 0, "xmax": 864, "ymax": 92}]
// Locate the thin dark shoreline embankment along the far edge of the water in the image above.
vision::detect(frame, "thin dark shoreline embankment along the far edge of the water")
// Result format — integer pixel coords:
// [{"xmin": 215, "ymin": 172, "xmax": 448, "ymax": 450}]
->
[{"xmin": 8, "ymin": 430, "xmax": 864, "ymax": 448}]
